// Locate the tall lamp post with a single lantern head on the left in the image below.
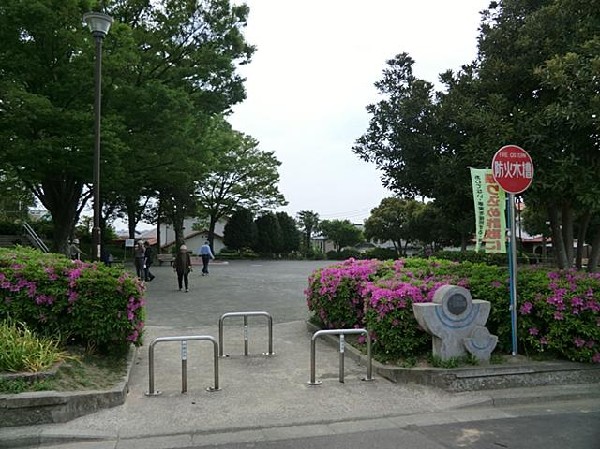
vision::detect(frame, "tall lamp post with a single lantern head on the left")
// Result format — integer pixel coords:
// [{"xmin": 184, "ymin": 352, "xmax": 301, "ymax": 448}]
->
[{"xmin": 83, "ymin": 12, "xmax": 113, "ymax": 260}]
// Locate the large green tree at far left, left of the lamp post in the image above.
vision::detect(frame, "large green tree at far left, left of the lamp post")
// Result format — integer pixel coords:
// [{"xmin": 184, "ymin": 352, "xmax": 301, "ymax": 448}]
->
[{"xmin": 0, "ymin": 0, "xmax": 93, "ymax": 251}]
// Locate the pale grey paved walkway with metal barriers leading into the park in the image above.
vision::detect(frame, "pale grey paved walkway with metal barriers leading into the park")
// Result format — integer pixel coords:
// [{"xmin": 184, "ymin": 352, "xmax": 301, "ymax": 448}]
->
[{"xmin": 0, "ymin": 261, "xmax": 600, "ymax": 449}]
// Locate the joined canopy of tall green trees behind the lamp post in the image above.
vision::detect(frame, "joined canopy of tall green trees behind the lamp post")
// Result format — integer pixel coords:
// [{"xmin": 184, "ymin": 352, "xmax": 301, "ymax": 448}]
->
[{"xmin": 0, "ymin": 0, "xmax": 254, "ymax": 250}]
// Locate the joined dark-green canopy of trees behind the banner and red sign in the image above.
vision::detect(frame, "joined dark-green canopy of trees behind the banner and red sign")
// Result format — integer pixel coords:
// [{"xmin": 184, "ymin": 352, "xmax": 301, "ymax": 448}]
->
[{"xmin": 353, "ymin": 0, "xmax": 600, "ymax": 270}]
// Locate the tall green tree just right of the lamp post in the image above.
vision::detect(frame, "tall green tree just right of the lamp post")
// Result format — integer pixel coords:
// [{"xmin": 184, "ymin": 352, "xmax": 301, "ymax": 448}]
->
[{"xmin": 110, "ymin": 0, "xmax": 254, "ymax": 236}]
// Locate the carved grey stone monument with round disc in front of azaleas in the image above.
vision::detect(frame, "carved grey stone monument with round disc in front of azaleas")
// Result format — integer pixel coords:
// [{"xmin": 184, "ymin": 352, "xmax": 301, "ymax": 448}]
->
[{"xmin": 413, "ymin": 285, "xmax": 498, "ymax": 362}]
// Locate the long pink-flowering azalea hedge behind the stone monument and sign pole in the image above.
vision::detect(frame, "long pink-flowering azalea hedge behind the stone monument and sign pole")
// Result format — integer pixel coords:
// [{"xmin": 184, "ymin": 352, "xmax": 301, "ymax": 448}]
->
[{"xmin": 306, "ymin": 258, "xmax": 600, "ymax": 363}]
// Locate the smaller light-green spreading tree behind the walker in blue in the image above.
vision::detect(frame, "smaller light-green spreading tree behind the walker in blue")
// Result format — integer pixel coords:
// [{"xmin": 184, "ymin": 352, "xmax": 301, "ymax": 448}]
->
[{"xmin": 196, "ymin": 118, "xmax": 287, "ymax": 248}]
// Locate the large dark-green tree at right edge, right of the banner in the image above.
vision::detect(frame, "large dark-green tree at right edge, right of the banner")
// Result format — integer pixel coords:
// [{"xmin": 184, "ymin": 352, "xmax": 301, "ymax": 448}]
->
[{"xmin": 478, "ymin": 0, "xmax": 600, "ymax": 270}]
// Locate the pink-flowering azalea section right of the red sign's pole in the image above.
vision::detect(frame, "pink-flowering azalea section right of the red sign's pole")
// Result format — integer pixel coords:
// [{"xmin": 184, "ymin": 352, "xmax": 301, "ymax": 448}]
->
[{"xmin": 518, "ymin": 270, "xmax": 600, "ymax": 363}]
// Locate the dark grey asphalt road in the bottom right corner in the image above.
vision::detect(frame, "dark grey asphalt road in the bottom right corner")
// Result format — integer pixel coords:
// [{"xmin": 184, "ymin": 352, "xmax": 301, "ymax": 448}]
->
[{"xmin": 189, "ymin": 404, "xmax": 600, "ymax": 449}]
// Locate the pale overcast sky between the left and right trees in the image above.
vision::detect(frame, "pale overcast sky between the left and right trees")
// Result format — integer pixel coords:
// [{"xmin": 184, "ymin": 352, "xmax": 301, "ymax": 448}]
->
[{"xmin": 229, "ymin": 0, "xmax": 489, "ymax": 223}]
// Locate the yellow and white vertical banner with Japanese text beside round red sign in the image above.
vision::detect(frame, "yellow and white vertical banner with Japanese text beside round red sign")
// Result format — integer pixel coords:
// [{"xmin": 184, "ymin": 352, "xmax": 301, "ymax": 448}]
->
[{"xmin": 471, "ymin": 168, "xmax": 506, "ymax": 253}]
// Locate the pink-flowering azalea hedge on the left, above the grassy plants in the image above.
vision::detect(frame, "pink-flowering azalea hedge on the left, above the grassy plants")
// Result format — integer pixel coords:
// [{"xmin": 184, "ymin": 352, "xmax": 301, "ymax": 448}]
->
[{"xmin": 0, "ymin": 248, "xmax": 145, "ymax": 352}]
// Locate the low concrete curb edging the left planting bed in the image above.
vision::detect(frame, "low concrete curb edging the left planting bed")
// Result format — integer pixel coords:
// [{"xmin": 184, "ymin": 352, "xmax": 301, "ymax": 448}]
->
[{"xmin": 0, "ymin": 347, "xmax": 137, "ymax": 428}]
